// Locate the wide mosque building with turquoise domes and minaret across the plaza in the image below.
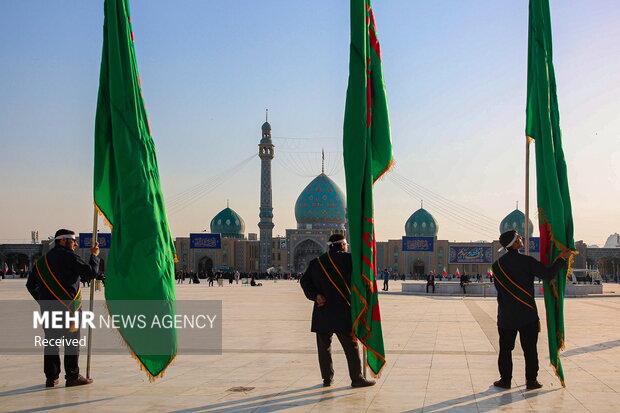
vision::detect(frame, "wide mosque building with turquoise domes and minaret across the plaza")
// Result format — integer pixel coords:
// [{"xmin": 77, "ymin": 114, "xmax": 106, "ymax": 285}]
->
[{"xmin": 168, "ymin": 119, "xmax": 538, "ymax": 276}]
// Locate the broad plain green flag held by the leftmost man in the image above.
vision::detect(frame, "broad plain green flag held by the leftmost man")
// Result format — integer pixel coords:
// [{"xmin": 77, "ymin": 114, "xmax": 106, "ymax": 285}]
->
[{"xmin": 94, "ymin": 0, "xmax": 177, "ymax": 379}]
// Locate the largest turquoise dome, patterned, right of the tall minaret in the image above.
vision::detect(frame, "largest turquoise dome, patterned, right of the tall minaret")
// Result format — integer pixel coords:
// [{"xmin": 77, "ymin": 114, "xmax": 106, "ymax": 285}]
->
[{"xmin": 295, "ymin": 174, "xmax": 346, "ymax": 229}]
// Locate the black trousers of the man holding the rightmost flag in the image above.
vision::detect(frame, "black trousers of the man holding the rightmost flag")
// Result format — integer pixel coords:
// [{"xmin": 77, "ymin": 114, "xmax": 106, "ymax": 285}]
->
[{"xmin": 497, "ymin": 321, "xmax": 539, "ymax": 381}]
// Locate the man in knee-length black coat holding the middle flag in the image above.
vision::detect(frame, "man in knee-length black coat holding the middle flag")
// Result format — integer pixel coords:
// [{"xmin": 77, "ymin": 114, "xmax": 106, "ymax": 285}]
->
[{"xmin": 300, "ymin": 234, "xmax": 375, "ymax": 387}]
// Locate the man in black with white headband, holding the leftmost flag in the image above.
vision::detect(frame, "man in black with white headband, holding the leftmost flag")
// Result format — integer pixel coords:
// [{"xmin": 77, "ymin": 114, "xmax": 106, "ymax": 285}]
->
[{"xmin": 26, "ymin": 229, "xmax": 99, "ymax": 387}]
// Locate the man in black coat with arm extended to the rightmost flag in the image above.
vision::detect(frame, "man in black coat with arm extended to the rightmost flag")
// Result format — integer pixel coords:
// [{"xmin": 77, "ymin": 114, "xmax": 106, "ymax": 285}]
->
[{"xmin": 493, "ymin": 230, "xmax": 571, "ymax": 390}]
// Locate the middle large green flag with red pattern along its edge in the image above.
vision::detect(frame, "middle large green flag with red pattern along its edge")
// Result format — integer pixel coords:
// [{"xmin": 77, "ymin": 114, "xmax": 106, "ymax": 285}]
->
[{"xmin": 343, "ymin": 0, "xmax": 393, "ymax": 376}]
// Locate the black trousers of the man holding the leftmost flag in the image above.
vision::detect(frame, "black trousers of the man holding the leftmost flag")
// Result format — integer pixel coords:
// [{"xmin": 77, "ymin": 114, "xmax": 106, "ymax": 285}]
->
[{"xmin": 43, "ymin": 329, "xmax": 80, "ymax": 380}]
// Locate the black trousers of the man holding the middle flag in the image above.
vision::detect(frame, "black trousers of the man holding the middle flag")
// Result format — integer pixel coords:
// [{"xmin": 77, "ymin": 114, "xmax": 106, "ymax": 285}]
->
[{"xmin": 316, "ymin": 333, "xmax": 362, "ymax": 381}]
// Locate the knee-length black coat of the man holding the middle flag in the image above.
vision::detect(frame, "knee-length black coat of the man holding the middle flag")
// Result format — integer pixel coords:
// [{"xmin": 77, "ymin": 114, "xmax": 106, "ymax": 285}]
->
[{"xmin": 299, "ymin": 251, "xmax": 353, "ymax": 334}]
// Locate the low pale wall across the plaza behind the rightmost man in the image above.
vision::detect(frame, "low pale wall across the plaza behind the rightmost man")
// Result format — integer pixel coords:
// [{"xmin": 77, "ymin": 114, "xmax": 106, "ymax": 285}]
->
[{"xmin": 401, "ymin": 281, "xmax": 603, "ymax": 297}]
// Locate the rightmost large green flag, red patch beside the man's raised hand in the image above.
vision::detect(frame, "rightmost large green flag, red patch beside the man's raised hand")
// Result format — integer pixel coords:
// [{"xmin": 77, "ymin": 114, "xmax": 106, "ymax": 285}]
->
[{"xmin": 525, "ymin": 0, "xmax": 575, "ymax": 386}]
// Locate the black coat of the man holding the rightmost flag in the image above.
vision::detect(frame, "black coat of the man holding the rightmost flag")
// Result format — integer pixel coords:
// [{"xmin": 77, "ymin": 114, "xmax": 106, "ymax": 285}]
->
[{"xmin": 494, "ymin": 248, "xmax": 566, "ymax": 330}]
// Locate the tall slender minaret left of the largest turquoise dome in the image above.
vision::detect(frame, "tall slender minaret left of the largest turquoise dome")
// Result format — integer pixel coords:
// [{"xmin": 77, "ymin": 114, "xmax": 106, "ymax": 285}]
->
[{"xmin": 258, "ymin": 109, "xmax": 274, "ymax": 272}]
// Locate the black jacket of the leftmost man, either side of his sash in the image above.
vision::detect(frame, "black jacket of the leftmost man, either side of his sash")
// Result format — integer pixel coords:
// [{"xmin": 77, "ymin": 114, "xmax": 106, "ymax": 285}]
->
[{"xmin": 26, "ymin": 245, "xmax": 99, "ymax": 300}]
